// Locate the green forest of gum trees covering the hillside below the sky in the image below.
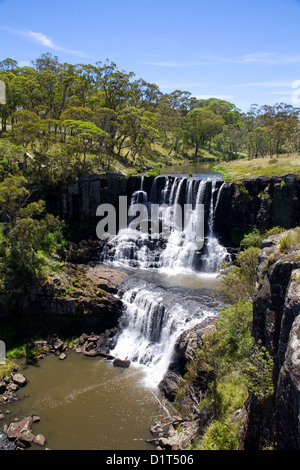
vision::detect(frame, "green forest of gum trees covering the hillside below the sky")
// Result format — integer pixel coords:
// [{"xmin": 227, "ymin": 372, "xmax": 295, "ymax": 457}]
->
[{"xmin": 0, "ymin": 53, "xmax": 300, "ymax": 184}]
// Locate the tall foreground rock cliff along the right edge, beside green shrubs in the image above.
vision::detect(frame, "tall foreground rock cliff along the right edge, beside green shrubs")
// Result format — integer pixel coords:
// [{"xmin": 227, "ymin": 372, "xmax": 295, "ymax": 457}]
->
[{"xmin": 240, "ymin": 231, "xmax": 300, "ymax": 450}]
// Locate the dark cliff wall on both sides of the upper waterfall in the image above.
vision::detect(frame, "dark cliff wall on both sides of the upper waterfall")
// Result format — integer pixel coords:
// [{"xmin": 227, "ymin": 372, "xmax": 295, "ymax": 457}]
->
[{"xmin": 35, "ymin": 173, "xmax": 300, "ymax": 246}]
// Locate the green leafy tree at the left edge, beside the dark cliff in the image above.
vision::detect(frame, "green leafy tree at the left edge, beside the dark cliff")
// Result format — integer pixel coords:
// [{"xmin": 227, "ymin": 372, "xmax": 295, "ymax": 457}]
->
[{"xmin": 0, "ymin": 176, "xmax": 64, "ymax": 287}]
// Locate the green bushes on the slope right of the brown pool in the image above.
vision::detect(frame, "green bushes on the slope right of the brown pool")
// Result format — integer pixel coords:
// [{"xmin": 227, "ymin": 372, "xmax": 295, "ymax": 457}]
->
[{"xmin": 175, "ymin": 300, "xmax": 274, "ymax": 450}]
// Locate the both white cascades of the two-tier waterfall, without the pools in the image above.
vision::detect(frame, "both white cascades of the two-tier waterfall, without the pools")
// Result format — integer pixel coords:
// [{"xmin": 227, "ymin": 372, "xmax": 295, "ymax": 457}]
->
[{"xmin": 102, "ymin": 176, "xmax": 227, "ymax": 386}]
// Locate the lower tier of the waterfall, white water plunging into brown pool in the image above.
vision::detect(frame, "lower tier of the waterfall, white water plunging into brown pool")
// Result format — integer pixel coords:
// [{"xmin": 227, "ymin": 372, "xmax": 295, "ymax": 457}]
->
[{"xmin": 111, "ymin": 285, "xmax": 215, "ymax": 387}]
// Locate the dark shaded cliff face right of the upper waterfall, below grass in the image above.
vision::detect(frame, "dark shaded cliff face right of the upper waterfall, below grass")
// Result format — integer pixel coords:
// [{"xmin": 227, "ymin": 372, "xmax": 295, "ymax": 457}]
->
[{"xmin": 215, "ymin": 173, "xmax": 300, "ymax": 241}]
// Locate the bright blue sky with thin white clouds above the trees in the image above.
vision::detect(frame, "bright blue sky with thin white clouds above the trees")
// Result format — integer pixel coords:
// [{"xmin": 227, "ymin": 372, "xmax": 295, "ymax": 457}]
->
[{"xmin": 0, "ymin": 0, "xmax": 300, "ymax": 111}]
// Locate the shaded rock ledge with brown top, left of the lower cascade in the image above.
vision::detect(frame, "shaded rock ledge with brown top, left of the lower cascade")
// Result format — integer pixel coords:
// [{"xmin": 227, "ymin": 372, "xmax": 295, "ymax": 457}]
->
[{"xmin": 0, "ymin": 264, "xmax": 125, "ymax": 347}]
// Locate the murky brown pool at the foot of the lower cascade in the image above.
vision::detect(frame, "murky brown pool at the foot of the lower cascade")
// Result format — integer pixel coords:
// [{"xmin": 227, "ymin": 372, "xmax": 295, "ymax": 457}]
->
[{"xmin": 3, "ymin": 351, "xmax": 175, "ymax": 450}]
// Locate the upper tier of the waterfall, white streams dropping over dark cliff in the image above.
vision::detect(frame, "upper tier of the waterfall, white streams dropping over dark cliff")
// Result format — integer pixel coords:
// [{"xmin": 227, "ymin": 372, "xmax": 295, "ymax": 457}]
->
[{"xmin": 101, "ymin": 176, "xmax": 227, "ymax": 273}]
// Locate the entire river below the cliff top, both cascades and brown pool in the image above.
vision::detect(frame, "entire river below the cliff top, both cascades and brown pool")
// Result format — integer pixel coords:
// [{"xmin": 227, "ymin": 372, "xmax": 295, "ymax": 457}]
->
[{"xmin": 0, "ymin": 164, "xmax": 226, "ymax": 450}]
